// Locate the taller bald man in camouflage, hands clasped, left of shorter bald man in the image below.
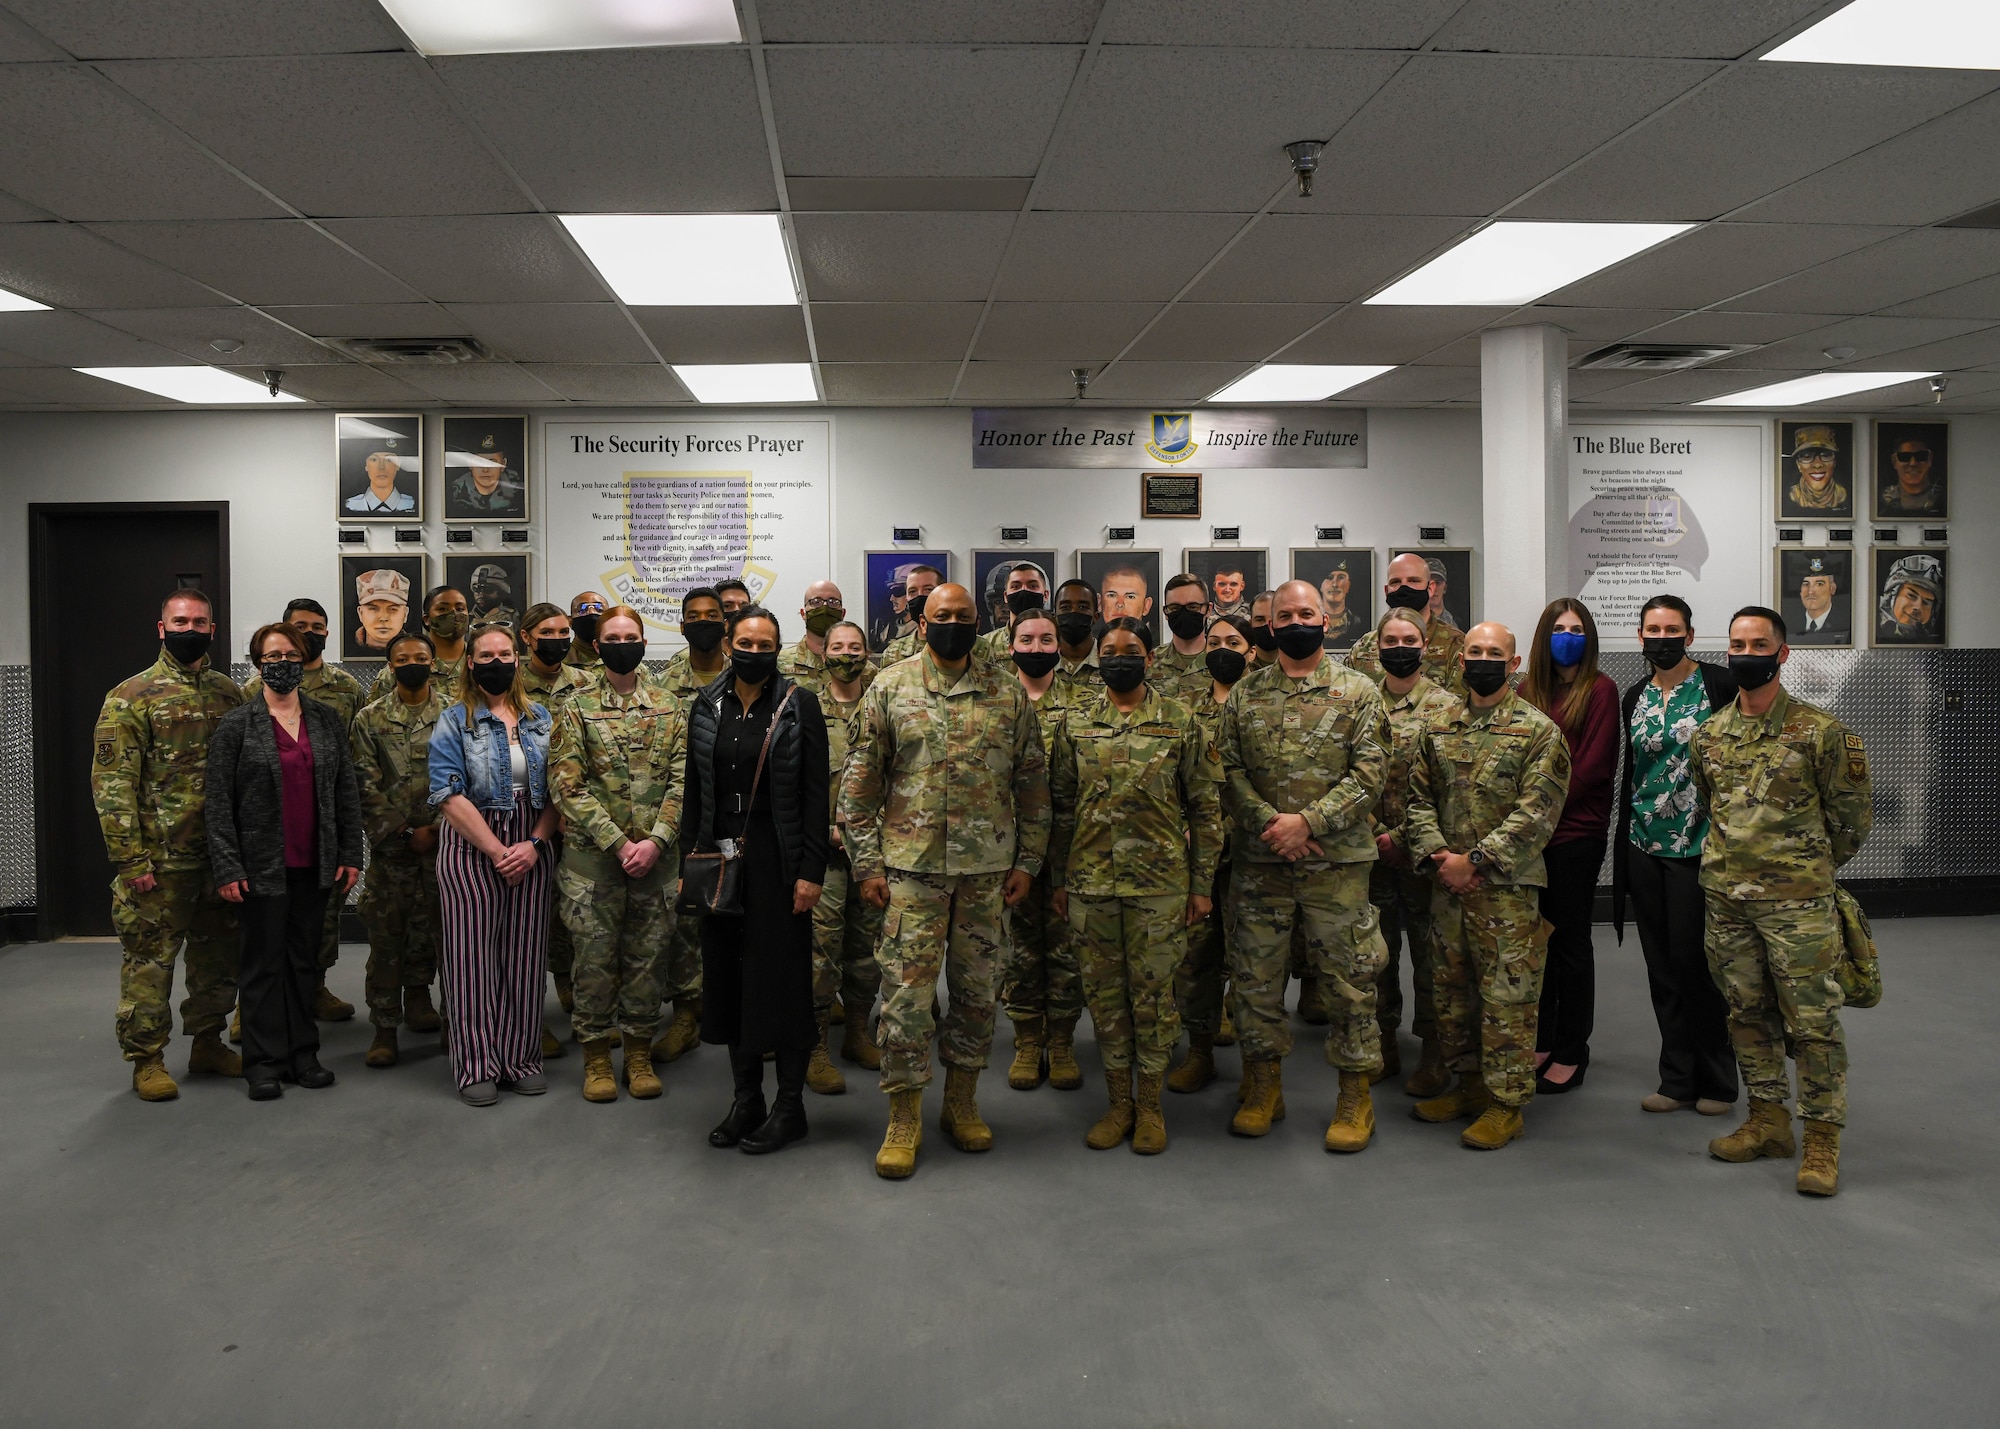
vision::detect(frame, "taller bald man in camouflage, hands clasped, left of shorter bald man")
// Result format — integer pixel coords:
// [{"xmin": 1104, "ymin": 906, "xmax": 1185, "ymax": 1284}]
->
[{"xmin": 1222, "ymin": 580, "xmax": 1388, "ymax": 1151}]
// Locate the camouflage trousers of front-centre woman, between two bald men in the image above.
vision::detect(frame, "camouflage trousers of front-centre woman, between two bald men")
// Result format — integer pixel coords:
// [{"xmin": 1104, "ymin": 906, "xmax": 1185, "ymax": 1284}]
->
[{"xmin": 1070, "ymin": 893, "xmax": 1188, "ymax": 1073}]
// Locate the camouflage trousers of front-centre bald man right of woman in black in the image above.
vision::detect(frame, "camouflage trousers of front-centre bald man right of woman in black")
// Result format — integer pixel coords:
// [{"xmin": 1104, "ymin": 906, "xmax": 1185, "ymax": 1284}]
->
[{"xmin": 876, "ymin": 869, "xmax": 1006, "ymax": 1091}]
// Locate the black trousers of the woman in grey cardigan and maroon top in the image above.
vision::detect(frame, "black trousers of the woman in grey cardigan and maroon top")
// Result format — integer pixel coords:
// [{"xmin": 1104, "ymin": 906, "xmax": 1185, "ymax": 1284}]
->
[{"xmin": 236, "ymin": 869, "xmax": 330, "ymax": 1081}]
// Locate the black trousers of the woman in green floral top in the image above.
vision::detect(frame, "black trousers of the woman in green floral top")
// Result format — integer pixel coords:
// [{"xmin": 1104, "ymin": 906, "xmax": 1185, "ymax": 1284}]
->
[{"xmin": 1626, "ymin": 849, "xmax": 1736, "ymax": 1101}]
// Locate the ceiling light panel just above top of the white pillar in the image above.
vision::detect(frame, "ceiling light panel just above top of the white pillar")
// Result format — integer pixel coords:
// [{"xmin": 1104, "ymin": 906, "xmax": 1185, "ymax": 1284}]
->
[{"xmin": 1368, "ymin": 222, "xmax": 1694, "ymax": 308}]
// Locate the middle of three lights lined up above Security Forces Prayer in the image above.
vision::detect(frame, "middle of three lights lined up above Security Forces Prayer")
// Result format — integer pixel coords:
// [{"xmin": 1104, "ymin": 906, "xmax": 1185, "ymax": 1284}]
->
[{"xmin": 562, "ymin": 214, "xmax": 798, "ymax": 308}]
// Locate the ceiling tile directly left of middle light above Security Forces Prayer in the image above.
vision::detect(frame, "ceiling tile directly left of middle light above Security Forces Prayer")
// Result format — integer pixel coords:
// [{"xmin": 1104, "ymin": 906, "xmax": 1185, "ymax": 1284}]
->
[{"xmin": 326, "ymin": 214, "xmax": 610, "ymax": 302}]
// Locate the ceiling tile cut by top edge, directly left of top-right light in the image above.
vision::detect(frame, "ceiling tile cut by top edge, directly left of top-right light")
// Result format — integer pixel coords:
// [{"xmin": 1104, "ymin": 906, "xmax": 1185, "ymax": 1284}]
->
[{"xmin": 1436, "ymin": 0, "xmax": 1826, "ymax": 60}]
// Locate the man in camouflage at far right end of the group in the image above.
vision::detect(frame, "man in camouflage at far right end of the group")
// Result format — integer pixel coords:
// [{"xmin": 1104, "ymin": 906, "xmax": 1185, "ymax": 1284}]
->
[{"xmin": 1690, "ymin": 606, "xmax": 1874, "ymax": 1195}]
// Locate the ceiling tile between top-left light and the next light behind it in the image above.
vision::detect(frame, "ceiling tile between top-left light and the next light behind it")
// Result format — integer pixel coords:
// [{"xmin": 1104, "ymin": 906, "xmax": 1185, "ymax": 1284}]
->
[{"xmin": 436, "ymin": 48, "xmax": 778, "ymax": 214}]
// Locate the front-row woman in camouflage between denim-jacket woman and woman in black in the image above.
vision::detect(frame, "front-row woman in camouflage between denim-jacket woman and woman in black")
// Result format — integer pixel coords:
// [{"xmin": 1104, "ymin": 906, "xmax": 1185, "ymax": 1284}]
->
[{"xmin": 548, "ymin": 606, "xmax": 688, "ymax": 1101}]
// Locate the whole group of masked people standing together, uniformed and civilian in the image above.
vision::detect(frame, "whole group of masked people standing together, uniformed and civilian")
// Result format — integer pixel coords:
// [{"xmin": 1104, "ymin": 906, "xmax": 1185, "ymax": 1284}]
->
[{"xmin": 96, "ymin": 556, "xmax": 1870, "ymax": 1195}]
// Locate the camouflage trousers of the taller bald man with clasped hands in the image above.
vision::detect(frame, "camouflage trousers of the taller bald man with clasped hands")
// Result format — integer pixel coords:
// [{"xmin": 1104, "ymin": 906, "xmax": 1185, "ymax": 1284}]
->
[{"xmin": 1228, "ymin": 861, "xmax": 1386, "ymax": 1073}]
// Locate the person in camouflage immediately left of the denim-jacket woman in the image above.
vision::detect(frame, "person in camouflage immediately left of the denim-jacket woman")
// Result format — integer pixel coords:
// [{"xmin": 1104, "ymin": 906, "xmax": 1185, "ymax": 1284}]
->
[{"xmin": 348, "ymin": 634, "xmax": 448, "ymax": 1067}]
